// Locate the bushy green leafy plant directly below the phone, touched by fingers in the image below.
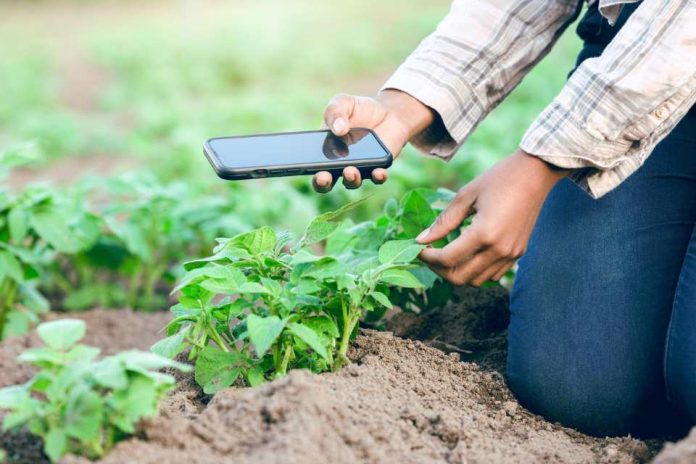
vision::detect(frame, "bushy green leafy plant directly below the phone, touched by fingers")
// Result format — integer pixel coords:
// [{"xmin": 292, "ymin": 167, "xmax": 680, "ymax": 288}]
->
[{"xmin": 152, "ymin": 198, "xmax": 430, "ymax": 393}]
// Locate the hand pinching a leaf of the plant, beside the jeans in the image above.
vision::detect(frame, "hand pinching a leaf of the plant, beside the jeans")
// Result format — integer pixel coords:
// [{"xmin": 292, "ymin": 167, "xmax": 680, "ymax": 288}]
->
[{"xmin": 416, "ymin": 150, "xmax": 568, "ymax": 286}]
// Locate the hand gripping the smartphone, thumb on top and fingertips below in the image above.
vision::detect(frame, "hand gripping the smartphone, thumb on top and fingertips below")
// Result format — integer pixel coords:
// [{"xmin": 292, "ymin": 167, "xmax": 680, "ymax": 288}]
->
[{"xmin": 312, "ymin": 90, "xmax": 433, "ymax": 193}]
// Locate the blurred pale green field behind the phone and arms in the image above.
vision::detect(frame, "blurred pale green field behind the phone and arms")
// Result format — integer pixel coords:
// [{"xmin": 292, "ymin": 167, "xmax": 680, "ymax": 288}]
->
[{"xmin": 0, "ymin": 0, "xmax": 579, "ymax": 217}]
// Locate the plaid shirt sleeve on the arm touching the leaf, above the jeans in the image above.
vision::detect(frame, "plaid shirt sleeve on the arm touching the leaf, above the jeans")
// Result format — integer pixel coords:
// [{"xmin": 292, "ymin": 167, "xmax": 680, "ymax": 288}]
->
[{"xmin": 521, "ymin": 0, "xmax": 696, "ymax": 198}]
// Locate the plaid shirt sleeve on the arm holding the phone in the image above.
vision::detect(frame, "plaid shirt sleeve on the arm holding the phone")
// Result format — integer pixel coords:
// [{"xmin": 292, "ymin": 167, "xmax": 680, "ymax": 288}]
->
[{"xmin": 383, "ymin": 0, "xmax": 582, "ymax": 159}]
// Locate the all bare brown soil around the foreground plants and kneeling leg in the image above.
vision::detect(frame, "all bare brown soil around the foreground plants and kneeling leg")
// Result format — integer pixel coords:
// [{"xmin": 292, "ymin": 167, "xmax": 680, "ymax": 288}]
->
[{"xmin": 0, "ymin": 289, "xmax": 696, "ymax": 464}]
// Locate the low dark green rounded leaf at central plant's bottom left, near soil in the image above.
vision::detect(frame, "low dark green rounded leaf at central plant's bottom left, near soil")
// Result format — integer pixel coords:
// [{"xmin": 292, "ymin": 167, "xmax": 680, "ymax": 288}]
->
[{"xmin": 194, "ymin": 346, "xmax": 245, "ymax": 395}]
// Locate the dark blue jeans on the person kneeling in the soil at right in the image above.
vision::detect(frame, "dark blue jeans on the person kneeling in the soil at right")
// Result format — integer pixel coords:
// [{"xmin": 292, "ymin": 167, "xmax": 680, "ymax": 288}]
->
[{"xmin": 507, "ymin": 109, "xmax": 696, "ymax": 436}]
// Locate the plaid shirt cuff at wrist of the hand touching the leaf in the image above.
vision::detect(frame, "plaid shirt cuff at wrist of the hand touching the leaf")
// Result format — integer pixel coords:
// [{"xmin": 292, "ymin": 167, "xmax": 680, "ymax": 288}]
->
[{"xmin": 520, "ymin": 102, "xmax": 642, "ymax": 198}]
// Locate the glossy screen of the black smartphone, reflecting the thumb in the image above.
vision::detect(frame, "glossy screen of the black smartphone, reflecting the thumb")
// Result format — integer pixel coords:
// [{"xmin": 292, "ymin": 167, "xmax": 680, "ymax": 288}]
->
[{"xmin": 208, "ymin": 129, "xmax": 391, "ymax": 171}]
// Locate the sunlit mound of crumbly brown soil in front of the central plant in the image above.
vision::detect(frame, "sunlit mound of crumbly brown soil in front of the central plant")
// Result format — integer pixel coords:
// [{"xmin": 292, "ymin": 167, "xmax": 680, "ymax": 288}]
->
[{"xmin": 89, "ymin": 331, "xmax": 649, "ymax": 463}]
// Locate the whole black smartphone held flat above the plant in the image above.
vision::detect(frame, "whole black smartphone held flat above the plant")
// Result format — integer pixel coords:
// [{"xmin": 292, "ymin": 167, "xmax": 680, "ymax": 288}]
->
[{"xmin": 203, "ymin": 129, "xmax": 393, "ymax": 180}]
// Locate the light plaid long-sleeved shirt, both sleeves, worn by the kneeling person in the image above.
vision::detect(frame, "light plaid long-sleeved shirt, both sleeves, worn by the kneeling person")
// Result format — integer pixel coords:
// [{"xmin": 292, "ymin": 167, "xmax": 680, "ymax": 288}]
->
[{"xmin": 384, "ymin": 0, "xmax": 696, "ymax": 197}]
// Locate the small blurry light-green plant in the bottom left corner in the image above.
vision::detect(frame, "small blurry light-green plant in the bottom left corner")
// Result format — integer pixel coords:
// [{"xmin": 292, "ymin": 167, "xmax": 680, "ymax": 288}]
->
[{"xmin": 0, "ymin": 319, "xmax": 190, "ymax": 462}]
